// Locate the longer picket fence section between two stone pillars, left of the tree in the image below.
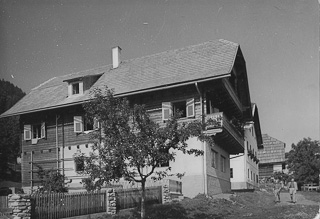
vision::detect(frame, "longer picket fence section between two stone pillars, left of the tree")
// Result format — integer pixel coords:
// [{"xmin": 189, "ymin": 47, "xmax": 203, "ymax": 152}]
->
[{"xmin": 32, "ymin": 191, "xmax": 107, "ymax": 219}]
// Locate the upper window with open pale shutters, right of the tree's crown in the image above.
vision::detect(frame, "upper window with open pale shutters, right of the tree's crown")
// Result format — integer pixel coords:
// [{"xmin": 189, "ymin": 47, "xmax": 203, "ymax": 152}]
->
[{"xmin": 162, "ymin": 98, "xmax": 195, "ymax": 120}]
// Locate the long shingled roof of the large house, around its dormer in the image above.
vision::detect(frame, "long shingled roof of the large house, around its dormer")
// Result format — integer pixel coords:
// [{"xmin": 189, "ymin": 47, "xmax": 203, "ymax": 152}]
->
[{"xmin": 0, "ymin": 39, "xmax": 241, "ymax": 117}]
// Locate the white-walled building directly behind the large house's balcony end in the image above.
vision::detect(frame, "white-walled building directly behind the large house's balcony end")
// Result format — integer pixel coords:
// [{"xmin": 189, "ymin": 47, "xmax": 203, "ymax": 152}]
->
[{"xmin": 230, "ymin": 104, "xmax": 263, "ymax": 190}]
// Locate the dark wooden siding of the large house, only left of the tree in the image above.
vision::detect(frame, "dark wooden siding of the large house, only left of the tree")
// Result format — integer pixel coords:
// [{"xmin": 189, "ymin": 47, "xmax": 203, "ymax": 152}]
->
[{"xmin": 21, "ymin": 107, "xmax": 89, "ymax": 186}]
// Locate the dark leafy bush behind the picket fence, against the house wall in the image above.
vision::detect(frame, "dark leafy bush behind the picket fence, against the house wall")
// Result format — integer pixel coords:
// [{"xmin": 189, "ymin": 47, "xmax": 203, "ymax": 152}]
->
[{"xmin": 36, "ymin": 165, "xmax": 68, "ymax": 193}]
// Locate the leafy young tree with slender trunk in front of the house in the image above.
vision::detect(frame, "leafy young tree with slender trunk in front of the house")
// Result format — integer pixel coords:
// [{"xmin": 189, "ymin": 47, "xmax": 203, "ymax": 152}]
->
[{"xmin": 79, "ymin": 88, "xmax": 211, "ymax": 218}]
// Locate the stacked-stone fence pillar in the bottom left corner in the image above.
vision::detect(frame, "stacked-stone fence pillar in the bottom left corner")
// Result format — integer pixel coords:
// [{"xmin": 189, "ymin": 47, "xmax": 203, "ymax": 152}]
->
[{"xmin": 8, "ymin": 194, "xmax": 31, "ymax": 219}]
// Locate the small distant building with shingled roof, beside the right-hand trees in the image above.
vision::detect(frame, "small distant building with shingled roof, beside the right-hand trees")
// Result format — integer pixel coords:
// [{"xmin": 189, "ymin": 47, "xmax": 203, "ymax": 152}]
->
[{"xmin": 258, "ymin": 134, "xmax": 286, "ymax": 179}]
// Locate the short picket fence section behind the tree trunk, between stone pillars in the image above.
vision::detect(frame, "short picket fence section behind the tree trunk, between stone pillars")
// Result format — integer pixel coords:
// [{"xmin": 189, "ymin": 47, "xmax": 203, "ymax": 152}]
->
[{"xmin": 116, "ymin": 186, "xmax": 162, "ymax": 210}]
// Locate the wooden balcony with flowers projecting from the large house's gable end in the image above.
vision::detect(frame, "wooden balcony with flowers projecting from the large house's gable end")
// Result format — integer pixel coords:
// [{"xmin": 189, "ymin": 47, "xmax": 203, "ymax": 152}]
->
[{"xmin": 205, "ymin": 112, "xmax": 244, "ymax": 154}]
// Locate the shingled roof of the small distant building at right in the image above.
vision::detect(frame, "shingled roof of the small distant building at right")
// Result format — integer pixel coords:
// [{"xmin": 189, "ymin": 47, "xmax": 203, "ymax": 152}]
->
[{"xmin": 258, "ymin": 134, "xmax": 285, "ymax": 164}]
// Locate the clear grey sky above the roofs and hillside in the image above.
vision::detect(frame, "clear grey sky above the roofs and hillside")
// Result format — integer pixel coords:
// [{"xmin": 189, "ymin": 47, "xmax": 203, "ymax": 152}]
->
[{"xmin": 0, "ymin": 0, "xmax": 320, "ymax": 151}]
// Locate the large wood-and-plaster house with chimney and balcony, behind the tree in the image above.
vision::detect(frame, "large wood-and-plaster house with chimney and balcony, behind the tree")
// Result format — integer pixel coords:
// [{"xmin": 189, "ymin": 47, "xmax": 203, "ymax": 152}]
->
[{"xmin": 1, "ymin": 40, "xmax": 252, "ymax": 197}]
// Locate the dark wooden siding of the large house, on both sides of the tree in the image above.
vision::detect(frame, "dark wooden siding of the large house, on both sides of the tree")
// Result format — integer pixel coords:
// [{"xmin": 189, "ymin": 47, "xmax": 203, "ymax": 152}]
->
[{"xmin": 21, "ymin": 84, "xmax": 245, "ymax": 189}]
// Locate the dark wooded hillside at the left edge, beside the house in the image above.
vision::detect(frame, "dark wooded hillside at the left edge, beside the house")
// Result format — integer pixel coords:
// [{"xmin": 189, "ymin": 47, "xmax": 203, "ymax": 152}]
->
[{"xmin": 0, "ymin": 79, "xmax": 25, "ymax": 181}]
